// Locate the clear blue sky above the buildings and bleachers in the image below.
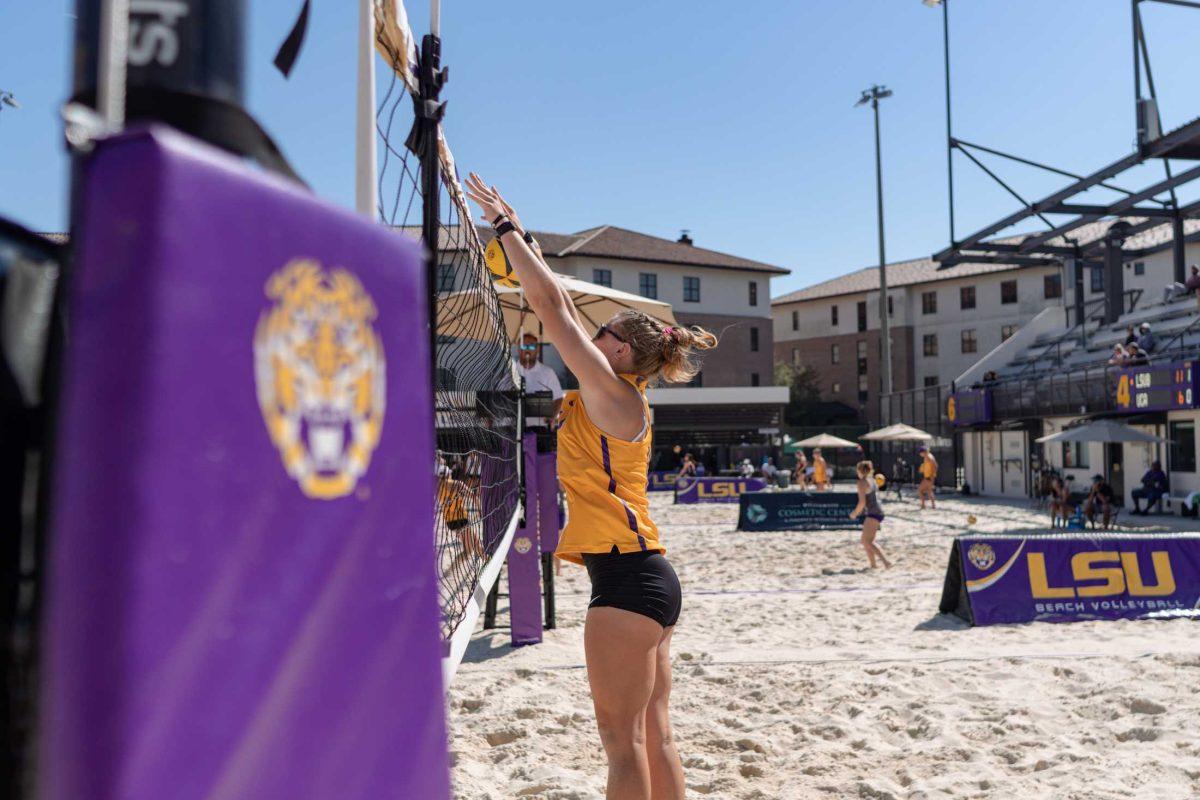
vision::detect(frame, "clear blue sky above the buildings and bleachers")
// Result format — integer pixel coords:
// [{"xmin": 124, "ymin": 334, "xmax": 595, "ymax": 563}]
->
[{"xmin": 0, "ymin": 0, "xmax": 1200, "ymax": 295}]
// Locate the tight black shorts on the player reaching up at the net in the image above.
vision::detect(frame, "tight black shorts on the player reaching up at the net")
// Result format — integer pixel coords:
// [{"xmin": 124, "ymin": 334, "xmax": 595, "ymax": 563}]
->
[{"xmin": 583, "ymin": 546, "xmax": 683, "ymax": 627}]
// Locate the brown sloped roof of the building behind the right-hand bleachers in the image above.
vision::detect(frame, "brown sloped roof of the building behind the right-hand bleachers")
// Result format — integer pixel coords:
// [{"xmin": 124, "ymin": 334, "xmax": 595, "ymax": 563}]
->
[{"xmin": 770, "ymin": 217, "xmax": 1200, "ymax": 306}]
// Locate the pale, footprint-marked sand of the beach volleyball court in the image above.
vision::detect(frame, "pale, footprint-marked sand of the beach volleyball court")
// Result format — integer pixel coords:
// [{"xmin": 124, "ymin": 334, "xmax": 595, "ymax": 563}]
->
[{"xmin": 450, "ymin": 497, "xmax": 1200, "ymax": 800}]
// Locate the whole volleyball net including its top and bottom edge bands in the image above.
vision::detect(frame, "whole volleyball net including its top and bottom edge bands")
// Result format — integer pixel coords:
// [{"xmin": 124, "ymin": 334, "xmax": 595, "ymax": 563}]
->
[{"xmin": 372, "ymin": 0, "xmax": 523, "ymax": 686}]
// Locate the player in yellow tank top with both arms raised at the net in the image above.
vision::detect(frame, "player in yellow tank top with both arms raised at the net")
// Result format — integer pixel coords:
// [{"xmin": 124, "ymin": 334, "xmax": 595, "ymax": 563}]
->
[{"xmin": 467, "ymin": 174, "xmax": 716, "ymax": 800}]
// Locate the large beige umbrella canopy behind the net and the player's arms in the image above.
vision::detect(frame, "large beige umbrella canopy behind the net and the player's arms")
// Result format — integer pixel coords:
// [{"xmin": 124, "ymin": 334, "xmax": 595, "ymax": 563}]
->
[{"xmin": 438, "ymin": 275, "xmax": 677, "ymax": 343}]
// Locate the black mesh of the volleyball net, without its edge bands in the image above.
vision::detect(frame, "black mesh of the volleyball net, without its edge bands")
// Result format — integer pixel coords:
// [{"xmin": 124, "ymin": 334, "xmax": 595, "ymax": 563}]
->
[{"xmin": 377, "ymin": 40, "xmax": 521, "ymax": 639}]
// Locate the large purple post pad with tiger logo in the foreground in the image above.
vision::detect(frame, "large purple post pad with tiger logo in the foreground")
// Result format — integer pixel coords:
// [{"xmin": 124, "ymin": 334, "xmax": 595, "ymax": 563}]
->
[{"xmin": 37, "ymin": 130, "xmax": 451, "ymax": 800}]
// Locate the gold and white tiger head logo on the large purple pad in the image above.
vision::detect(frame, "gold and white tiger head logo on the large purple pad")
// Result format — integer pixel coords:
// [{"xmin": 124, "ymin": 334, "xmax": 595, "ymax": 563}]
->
[{"xmin": 254, "ymin": 259, "xmax": 385, "ymax": 500}]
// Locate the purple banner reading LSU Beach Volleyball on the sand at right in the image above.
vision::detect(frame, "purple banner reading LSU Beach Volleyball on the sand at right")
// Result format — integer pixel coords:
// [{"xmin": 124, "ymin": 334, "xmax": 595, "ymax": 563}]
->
[{"xmin": 940, "ymin": 534, "xmax": 1200, "ymax": 625}]
